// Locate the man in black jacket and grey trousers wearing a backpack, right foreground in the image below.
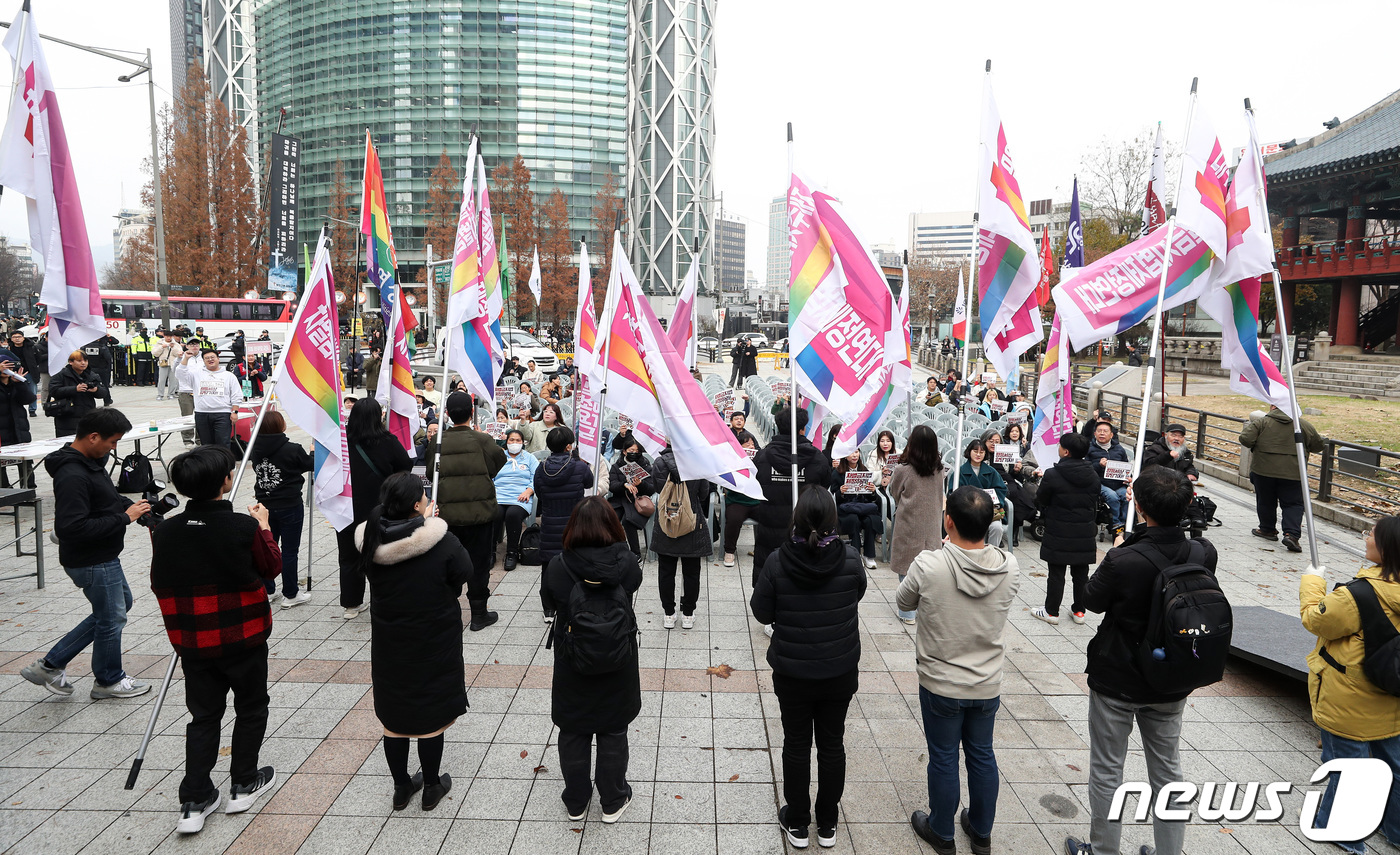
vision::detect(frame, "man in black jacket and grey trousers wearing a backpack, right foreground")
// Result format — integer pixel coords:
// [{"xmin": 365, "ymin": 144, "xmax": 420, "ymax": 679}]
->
[{"xmin": 1065, "ymin": 466, "xmax": 1217, "ymax": 855}]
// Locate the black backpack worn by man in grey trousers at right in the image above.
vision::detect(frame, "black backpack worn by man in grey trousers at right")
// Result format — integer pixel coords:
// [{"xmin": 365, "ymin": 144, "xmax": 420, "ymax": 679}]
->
[{"xmin": 1130, "ymin": 540, "xmax": 1235, "ymax": 694}]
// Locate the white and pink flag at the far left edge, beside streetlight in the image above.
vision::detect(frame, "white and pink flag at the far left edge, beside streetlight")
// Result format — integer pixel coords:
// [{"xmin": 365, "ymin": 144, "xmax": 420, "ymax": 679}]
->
[{"xmin": 0, "ymin": 3, "xmax": 106, "ymax": 374}]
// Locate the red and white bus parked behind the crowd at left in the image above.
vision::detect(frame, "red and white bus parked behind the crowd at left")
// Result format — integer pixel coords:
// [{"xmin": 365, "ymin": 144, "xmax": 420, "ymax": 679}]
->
[{"xmin": 101, "ymin": 288, "xmax": 297, "ymax": 343}]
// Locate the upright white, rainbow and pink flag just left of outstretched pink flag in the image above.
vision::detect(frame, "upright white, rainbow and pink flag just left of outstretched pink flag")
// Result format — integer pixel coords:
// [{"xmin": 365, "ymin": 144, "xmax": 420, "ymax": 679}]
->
[{"xmin": 977, "ymin": 74, "xmax": 1044, "ymax": 376}]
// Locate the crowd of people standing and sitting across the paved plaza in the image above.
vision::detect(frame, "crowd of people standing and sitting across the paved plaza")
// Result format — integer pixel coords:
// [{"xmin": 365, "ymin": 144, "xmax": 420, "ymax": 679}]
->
[{"xmin": 16, "ymin": 333, "xmax": 1400, "ymax": 855}]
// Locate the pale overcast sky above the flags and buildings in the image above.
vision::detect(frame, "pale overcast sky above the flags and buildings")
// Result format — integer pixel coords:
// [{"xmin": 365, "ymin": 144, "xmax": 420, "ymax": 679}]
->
[{"xmin": 0, "ymin": 0, "xmax": 1400, "ymax": 288}]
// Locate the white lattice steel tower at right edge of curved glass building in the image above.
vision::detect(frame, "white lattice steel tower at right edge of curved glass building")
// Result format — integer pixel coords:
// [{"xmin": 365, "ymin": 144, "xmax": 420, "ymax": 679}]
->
[{"xmin": 627, "ymin": 0, "xmax": 715, "ymax": 294}]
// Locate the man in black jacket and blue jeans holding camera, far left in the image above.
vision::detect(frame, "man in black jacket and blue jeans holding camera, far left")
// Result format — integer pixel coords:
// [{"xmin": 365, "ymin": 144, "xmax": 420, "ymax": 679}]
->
[{"xmin": 20, "ymin": 407, "xmax": 151, "ymax": 700}]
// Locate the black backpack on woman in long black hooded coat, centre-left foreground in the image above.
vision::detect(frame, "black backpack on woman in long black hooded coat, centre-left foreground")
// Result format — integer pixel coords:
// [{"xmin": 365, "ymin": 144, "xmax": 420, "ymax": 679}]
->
[{"xmin": 545, "ymin": 557, "xmax": 638, "ymax": 676}]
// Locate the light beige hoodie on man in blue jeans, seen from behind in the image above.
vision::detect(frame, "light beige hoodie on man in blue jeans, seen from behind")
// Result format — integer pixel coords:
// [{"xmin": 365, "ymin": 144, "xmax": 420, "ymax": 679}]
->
[{"xmin": 895, "ymin": 543, "xmax": 1021, "ymax": 700}]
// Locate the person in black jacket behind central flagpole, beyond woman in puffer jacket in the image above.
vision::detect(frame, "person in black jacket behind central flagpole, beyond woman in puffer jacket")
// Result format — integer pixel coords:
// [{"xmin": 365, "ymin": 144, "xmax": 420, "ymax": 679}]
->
[{"xmin": 749, "ymin": 407, "xmax": 832, "ymax": 584}]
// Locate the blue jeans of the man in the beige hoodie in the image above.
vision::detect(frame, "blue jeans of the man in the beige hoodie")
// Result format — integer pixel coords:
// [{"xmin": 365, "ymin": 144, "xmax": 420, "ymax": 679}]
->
[{"xmin": 918, "ymin": 686, "xmax": 1001, "ymax": 840}]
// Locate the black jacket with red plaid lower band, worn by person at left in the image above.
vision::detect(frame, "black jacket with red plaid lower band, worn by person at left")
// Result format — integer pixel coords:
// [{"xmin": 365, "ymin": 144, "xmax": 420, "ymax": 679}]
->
[{"xmin": 151, "ymin": 501, "xmax": 281, "ymax": 659}]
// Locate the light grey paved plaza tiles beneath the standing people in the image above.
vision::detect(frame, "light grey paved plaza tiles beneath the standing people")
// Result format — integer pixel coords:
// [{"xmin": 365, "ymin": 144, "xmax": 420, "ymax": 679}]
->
[{"xmin": 0, "ymin": 390, "xmax": 1390, "ymax": 855}]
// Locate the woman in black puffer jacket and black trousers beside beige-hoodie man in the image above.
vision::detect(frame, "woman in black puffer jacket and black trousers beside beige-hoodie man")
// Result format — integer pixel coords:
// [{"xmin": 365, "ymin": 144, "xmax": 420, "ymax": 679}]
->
[{"xmin": 749, "ymin": 487, "xmax": 865, "ymax": 848}]
